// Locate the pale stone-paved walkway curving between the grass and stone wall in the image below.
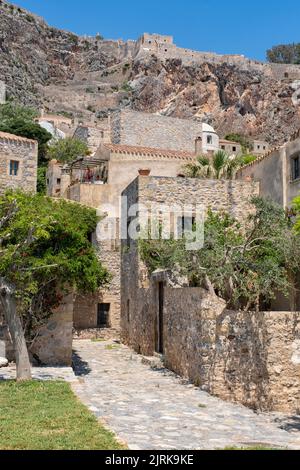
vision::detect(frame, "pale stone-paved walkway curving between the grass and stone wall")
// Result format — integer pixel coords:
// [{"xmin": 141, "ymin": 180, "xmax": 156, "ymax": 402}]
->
[{"xmin": 72, "ymin": 341, "xmax": 300, "ymax": 450}]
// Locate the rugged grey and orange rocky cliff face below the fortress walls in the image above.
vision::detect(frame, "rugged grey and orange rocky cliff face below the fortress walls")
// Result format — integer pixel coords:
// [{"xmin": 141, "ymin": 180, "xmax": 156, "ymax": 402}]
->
[{"xmin": 0, "ymin": 0, "xmax": 300, "ymax": 144}]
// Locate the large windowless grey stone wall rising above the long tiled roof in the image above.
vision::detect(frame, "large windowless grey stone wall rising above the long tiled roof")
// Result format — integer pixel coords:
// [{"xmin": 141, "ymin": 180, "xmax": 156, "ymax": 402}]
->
[{"xmin": 111, "ymin": 110, "xmax": 202, "ymax": 152}]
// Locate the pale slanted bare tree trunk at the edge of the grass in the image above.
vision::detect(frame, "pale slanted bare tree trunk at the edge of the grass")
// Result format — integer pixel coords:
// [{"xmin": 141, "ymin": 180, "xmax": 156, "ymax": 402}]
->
[{"xmin": 0, "ymin": 279, "xmax": 32, "ymax": 381}]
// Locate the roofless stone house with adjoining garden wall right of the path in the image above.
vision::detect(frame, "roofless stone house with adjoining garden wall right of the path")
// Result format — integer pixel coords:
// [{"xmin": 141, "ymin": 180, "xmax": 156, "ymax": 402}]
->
[{"xmin": 121, "ymin": 177, "xmax": 300, "ymax": 413}]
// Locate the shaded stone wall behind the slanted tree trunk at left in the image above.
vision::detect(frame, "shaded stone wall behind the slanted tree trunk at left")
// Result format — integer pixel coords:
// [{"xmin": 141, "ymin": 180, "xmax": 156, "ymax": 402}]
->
[{"xmin": 0, "ymin": 295, "xmax": 73, "ymax": 366}]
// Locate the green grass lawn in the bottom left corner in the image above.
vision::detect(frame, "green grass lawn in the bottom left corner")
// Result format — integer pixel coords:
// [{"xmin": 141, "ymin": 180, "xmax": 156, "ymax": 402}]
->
[{"xmin": 0, "ymin": 381, "xmax": 124, "ymax": 450}]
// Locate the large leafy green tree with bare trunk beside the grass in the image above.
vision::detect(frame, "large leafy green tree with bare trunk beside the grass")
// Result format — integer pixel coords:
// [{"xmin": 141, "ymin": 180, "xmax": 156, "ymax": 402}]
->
[{"xmin": 0, "ymin": 192, "xmax": 109, "ymax": 380}]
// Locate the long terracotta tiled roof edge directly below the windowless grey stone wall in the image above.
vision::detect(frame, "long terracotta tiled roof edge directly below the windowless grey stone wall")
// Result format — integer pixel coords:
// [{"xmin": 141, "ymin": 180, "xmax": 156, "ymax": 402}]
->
[{"xmin": 104, "ymin": 144, "xmax": 196, "ymax": 160}]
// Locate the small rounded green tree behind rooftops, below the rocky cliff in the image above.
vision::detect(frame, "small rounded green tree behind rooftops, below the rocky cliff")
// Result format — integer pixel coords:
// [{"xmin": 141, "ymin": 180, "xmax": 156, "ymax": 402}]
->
[{"xmin": 48, "ymin": 137, "xmax": 89, "ymax": 163}]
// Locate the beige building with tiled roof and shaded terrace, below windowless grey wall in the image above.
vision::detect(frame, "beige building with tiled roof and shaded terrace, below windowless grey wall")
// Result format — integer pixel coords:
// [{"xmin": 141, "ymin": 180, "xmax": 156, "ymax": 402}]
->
[{"xmin": 47, "ymin": 140, "xmax": 195, "ymax": 334}]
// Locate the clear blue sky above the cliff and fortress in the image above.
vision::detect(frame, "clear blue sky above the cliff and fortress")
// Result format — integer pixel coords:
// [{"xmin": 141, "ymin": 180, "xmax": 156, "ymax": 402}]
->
[{"xmin": 14, "ymin": 0, "xmax": 300, "ymax": 60}]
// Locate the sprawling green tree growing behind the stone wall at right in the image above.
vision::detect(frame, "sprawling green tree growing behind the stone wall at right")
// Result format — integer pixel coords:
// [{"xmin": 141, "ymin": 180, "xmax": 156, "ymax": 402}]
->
[{"xmin": 139, "ymin": 197, "xmax": 300, "ymax": 311}]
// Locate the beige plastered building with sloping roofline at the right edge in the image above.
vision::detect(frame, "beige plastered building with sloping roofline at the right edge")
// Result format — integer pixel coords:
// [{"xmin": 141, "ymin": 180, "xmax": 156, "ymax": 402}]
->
[{"xmin": 237, "ymin": 135, "xmax": 300, "ymax": 208}]
